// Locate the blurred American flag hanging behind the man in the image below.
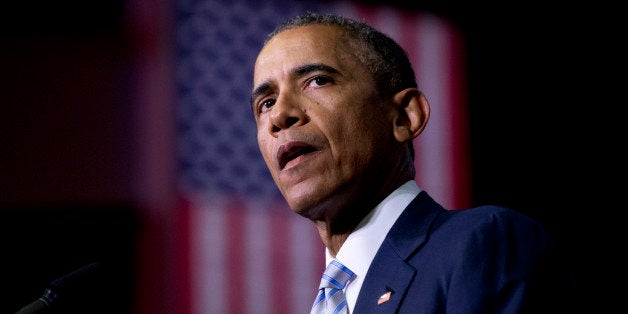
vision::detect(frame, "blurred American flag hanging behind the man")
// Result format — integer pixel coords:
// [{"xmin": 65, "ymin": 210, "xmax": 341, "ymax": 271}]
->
[{"xmin": 176, "ymin": 0, "xmax": 469, "ymax": 314}]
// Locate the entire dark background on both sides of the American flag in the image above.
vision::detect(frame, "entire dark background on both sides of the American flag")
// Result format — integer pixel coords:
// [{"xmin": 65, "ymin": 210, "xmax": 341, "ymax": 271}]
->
[{"xmin": 0, "ymin": 0, "xmax": 626, "ymax": 312}]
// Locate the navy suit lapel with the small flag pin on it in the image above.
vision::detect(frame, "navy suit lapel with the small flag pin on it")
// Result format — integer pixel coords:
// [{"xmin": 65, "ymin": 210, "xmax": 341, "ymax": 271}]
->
[{"xmin": 352, "ymin": 191, "xmax": 444, "ymax": 314}]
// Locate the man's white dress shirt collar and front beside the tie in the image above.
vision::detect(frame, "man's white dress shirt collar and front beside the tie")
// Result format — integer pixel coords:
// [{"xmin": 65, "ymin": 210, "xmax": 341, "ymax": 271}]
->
[{"xmin": 325, "ymin": 180, "xmax": 421, "ymax": 313}]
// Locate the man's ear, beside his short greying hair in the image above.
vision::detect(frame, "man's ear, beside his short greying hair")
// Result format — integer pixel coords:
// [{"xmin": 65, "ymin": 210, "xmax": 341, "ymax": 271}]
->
[{"xmin": 393, "ymin": 88, "xmax": 430, "ymax": 143}]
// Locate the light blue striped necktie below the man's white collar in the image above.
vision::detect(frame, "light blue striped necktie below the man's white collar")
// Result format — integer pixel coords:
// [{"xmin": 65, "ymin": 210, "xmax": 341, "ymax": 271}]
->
[{"xmin": 310, "ymin": 260, "xmax": 355, "ymax": 314}]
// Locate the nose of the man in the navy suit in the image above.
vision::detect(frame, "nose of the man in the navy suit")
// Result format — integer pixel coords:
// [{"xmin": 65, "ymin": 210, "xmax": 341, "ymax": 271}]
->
[{"xmin": 269, "ymin": 94, "xmax": 307, "ymax": 134}]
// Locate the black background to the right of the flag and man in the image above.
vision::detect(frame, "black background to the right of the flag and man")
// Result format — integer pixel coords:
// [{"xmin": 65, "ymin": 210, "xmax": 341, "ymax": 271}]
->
[{"xmin": 427, "ymin": 1, "xmax": 627, "ymax": 313}]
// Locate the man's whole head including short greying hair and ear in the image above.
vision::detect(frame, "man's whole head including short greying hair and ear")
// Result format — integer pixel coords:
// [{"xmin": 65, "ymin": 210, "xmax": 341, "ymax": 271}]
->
[{"xmin": 251, "ymin": 14, "xmax": 429, "ymax": 227}]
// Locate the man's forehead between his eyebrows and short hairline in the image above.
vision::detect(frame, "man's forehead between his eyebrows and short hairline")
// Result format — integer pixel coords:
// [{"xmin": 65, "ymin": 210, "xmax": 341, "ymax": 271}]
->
[{"xmin": 250, "ymin": 25, "xmax": 358, "ymax": 82}]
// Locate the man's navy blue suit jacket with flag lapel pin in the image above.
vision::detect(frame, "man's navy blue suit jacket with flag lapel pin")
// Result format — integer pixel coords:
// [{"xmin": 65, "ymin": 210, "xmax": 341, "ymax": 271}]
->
[{"xmin": 352, "ymin": 191, "xmax": 572, "ymax": 314}]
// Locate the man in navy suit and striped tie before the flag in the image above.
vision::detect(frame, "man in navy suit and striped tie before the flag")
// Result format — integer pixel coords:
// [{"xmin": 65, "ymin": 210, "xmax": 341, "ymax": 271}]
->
[{"xmin": 251, "ymin": 13, "xmax": 576, "ymax": 314}]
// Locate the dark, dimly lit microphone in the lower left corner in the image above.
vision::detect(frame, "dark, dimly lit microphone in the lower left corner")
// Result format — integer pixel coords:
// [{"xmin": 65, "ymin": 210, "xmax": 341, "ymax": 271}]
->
[{"xmin": 15, "ymin": 263, "xmax": 100, "ymax": 314}]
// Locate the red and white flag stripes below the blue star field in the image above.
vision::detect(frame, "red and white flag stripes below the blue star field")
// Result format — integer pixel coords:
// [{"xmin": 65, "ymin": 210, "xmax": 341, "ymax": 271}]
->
[{"xmin": 189, "ymin": 197, "xmax": 324, "ymax": 314}]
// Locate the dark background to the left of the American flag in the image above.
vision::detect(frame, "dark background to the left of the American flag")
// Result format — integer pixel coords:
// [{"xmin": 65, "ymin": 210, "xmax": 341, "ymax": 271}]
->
[{"xmin": 0, "ymin": 0, "xmax": 144, "ymax": 314}]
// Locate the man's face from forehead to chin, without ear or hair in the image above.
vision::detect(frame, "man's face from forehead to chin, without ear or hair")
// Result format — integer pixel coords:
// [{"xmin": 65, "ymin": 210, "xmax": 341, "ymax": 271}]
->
[{"xmin": 252, "ymin": 25, "xmax": 393, "ymax": 219}]
